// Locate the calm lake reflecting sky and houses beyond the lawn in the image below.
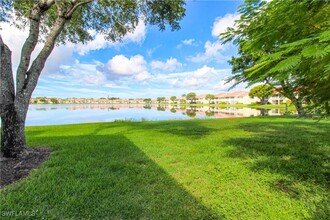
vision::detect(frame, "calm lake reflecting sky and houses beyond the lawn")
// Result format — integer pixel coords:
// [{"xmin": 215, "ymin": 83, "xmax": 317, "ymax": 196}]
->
[{"xmin": 26, "ymin": 104, "xmax": 284, "ymax": 126}]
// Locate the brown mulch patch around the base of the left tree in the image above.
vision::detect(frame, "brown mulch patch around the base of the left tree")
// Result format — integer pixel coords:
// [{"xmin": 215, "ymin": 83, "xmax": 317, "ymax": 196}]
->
[{"xmin": 0, "ymin": 148, "xmax": 52, "ymax": 188}]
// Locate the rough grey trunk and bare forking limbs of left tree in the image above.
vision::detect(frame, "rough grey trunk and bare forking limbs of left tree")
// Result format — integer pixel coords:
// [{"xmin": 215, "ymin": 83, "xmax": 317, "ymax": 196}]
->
[{"xmin": 0, "ymin": 0, "xmax": 81, "ymax": 157}]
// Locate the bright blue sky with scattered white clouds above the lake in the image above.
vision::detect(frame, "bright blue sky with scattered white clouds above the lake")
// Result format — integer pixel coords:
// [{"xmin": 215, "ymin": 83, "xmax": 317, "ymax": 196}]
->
[{"xmin": 0, "ymin": 0, "xmax": 245, "ymax": 98}]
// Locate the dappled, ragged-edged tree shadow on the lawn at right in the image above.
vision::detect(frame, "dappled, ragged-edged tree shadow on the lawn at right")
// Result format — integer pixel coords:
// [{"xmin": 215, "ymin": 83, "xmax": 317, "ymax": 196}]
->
[{"xmin": 226, "ymin": 122, "xmax": 330, "ymax": 219}]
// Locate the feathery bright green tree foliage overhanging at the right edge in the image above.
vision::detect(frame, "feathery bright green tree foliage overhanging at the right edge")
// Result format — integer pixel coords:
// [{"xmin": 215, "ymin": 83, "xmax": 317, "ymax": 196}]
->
[{"xmin": 221, "ymin": 0, "xmax": 330, "ymax": 115}]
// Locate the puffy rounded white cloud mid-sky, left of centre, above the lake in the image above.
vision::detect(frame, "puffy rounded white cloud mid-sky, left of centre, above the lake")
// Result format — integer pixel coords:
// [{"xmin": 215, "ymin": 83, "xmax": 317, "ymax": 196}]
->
[{"xmin": 106, "ymin": 55, "xmax": 147, "ymax": 76}]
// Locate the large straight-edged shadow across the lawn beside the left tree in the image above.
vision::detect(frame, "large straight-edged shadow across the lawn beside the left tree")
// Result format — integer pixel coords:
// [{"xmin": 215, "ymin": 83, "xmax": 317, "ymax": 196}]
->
[{"xmin": 1, "ymin": 134, "xmax": 219, "ymax": 219}]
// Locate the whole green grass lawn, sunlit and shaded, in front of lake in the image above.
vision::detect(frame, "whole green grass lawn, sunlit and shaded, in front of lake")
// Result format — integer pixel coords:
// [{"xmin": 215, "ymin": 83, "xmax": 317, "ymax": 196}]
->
[{"xmin": 0, "ymin": 117, "xmax": 330, "ymax": 219}]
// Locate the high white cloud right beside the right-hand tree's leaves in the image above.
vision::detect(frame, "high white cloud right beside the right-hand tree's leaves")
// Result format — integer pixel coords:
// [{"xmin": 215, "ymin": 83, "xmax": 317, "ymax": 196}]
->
[{"xmin": 212, "ymin": 13, "xmax": 240, "ymax": 37}]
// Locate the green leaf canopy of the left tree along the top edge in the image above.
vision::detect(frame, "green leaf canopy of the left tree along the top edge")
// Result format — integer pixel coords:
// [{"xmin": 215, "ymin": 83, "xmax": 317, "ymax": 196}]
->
[{"xmin": 5, "ymin": 0, "xmax": 185, "ymax": 43}]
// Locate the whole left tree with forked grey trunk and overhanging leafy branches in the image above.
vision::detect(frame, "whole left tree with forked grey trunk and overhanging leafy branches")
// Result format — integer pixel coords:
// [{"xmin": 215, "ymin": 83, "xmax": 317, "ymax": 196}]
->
[{"xmin": 0, "ymin": 0, "xmax": 185, "ymax": 157}]
